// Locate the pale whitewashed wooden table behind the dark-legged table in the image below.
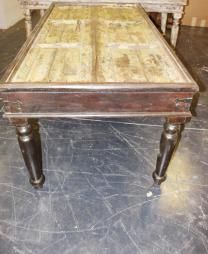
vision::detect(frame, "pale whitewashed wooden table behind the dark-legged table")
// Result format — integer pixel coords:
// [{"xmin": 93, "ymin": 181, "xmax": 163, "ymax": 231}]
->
[{"xmin": 19, "ymin": 0, "xmax": 187, "ymax": 47}]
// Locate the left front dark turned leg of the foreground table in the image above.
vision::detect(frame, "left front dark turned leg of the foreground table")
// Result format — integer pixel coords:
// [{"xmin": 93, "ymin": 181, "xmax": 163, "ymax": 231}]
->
[{"xmin": 13, "ymin": 119, "xmax": 45, "ymax": 187}]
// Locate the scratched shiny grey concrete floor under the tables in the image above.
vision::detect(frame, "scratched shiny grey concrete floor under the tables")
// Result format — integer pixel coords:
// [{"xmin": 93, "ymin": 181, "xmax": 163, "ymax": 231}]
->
[{"xmin": 0, "ymin": 14, "xmax": 208, "ymax": 254}]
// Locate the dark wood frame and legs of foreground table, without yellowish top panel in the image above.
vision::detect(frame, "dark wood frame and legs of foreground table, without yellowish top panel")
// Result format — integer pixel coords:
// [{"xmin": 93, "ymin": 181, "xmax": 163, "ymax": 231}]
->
[{"xmin": 1, "ymin": 2, "xmax": 198, "ymax": 187}]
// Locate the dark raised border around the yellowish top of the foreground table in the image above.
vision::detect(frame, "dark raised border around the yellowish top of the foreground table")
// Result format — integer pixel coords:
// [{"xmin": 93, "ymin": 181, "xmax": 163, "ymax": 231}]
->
[{"xmin": 0, "ymin": 2, "xmax": 199, "ymax": 92}]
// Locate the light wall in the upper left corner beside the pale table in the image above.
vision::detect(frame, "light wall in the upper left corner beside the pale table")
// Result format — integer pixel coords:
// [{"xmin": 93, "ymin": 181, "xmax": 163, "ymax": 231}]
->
[{"xmin": 0, "ymin": 0, "xmax": 23, "ymax": 29}]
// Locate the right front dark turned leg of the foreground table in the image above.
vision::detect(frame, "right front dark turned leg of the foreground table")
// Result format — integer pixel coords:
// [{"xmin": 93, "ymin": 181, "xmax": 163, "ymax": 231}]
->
[{"xmin": 153, "ymin": 120, "xmax": 181, "ymax": 184}]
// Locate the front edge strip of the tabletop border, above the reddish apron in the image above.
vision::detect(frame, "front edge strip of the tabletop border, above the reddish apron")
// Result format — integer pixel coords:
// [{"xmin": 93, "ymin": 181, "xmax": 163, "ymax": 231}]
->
[{"xmin": 1, "ymin": 82, "xmax": 197, "ymax": 92}]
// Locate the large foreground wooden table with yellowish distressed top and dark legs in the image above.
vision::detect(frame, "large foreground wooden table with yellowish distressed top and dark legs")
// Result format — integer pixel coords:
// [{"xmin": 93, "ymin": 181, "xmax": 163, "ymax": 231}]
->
[{"xmin": 1, "ymin": 3, "xmax": 198, "ymax": 186}]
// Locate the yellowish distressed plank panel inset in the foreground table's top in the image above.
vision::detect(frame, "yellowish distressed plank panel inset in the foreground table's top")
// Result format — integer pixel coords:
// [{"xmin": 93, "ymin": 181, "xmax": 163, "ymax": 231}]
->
[{"xmin": 10, "ymin": 4, "xmax": 189, "ymax": 84}]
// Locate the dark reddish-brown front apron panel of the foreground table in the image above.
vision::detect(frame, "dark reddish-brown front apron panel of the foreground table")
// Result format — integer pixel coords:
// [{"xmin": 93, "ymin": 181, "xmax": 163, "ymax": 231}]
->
[{"xmin": 4, "ymin": 91, "xmax": 194, "ymax": 115}]
